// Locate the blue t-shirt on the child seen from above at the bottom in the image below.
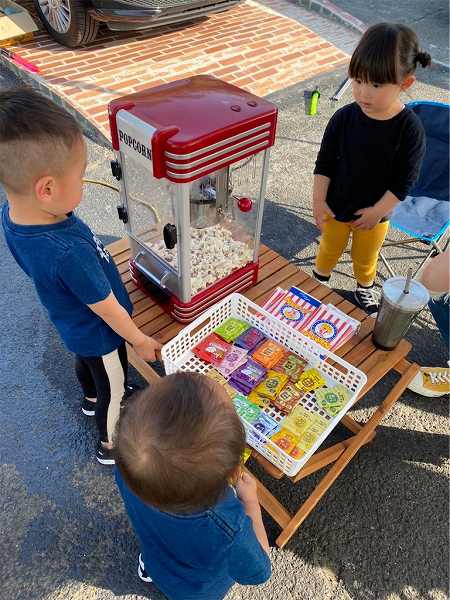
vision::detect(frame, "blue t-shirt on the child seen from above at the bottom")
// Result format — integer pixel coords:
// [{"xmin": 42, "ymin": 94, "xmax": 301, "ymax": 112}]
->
[{"xmin": 116, "ymin": 469, "xmax": 271, "ymax": 600}]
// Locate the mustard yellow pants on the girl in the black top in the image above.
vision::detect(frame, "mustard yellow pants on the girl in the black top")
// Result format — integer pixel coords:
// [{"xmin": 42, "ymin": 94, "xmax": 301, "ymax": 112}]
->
[{"xmin": 315, "ymin": 217, "xmax": 389, "ymax": 286}]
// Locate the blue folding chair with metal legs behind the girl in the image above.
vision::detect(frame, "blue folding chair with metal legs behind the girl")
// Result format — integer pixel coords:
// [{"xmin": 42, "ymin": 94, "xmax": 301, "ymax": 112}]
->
[{"xmin": 380, "ymin": 100, "xmax": 450, "ymax": 277}]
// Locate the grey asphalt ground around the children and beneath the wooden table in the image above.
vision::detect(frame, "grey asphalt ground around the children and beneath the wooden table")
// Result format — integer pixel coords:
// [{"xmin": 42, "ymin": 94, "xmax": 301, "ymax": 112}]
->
[{"xmin": 0, "ymin": 2, "xmax": 449, "ymax": 600}]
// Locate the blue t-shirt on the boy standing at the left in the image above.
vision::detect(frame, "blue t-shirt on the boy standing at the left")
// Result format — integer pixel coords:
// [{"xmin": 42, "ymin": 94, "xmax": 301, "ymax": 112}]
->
[{"xmin": 2, "ymin": 203, "xmax": 132, "ymax": 356}]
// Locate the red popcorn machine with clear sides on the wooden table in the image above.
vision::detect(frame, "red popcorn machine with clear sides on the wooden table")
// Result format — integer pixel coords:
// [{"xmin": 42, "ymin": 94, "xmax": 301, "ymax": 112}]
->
[{"xmin": 109, "ymin": 75, "xmax": 277, "ymax": 323}]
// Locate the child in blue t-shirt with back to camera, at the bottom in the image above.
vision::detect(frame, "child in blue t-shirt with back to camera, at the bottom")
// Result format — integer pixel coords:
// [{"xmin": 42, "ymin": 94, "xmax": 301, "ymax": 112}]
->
[{"xmin": 114, "ymin": 373, "xmax": 271, "ymax": 600}]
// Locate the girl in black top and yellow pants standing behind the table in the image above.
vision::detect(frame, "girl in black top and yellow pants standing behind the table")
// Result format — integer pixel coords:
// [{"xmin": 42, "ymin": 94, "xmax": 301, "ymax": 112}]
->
[{"xmin": 313, "ymin": 23, "xmax": 431, "ymax": 314}]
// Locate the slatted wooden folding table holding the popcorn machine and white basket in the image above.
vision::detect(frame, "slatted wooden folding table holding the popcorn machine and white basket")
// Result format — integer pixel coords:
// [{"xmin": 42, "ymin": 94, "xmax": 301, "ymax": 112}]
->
[{"xmin": 108, "ymin": 239, "xmax": 418, "ymax": 548}]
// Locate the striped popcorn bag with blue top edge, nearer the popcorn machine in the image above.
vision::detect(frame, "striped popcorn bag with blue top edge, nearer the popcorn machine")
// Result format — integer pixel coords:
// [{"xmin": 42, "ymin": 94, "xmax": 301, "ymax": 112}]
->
[{"xmin": 264, "ymin": 287, "xmax": 321, "ymax": 330}]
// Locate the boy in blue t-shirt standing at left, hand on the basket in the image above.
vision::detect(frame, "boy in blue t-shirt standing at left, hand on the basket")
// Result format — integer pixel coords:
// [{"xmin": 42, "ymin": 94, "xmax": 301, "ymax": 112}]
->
[{"xmin": 0, "ymin": 89, "xmax": 160, "ymax": 464}]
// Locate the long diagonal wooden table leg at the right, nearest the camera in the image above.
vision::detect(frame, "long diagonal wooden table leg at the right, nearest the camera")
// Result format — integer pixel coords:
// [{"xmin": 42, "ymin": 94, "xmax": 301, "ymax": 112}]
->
[{"xmin": 276, "ymin": 363, "xmax": 419, "ymax": 548}]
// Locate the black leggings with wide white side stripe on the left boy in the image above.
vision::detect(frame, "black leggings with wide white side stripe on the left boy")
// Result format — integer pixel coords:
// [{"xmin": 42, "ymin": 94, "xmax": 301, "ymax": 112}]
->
[{"xmin": 75, "ymin": 342, "xmax": 128, "ymax": 442}]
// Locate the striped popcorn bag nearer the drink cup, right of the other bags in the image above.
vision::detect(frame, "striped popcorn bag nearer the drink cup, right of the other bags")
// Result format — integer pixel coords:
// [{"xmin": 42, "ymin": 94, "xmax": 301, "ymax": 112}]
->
[{"xmin": 302, "ymin": 304, "xmax": 359, "ymax": 350}]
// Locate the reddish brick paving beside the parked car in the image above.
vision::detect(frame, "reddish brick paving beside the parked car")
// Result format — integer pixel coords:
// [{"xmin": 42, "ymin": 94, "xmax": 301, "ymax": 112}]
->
[{"xmin": 1, "ymin": 0, "xmax": 353, "ymax": 137}]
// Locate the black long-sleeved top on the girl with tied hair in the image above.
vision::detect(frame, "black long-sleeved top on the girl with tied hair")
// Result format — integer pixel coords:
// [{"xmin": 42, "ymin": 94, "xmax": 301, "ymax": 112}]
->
[{"xmin": 314, "ymin": 102, "xmax": 425, "ymax": 221}]
